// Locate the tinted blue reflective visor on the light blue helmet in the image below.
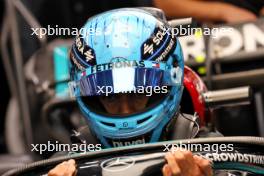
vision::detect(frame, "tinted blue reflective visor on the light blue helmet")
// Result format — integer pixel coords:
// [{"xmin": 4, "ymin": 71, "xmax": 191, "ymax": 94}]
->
[{"xmin": 70, "ymin": 61, "xmax": 182, "ymax": 96}]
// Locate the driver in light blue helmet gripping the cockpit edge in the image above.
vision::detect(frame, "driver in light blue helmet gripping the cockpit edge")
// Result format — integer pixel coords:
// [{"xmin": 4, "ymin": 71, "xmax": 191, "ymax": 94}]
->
[{"xmin": 48, "ymin": 8, "xmax": 217, "ymax": 176}]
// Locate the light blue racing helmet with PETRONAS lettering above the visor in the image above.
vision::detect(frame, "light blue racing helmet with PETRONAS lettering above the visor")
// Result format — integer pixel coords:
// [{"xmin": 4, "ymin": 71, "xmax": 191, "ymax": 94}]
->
[{"xmin": 70, "ymin": 8, "xmax": 184, "ymax": 147}]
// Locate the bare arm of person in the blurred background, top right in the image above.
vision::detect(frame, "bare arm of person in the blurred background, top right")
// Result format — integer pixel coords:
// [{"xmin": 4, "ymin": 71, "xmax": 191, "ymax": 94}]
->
[{"xmin": 153, "ymin": 0, "xmax": 256, "ymax": 22}]
